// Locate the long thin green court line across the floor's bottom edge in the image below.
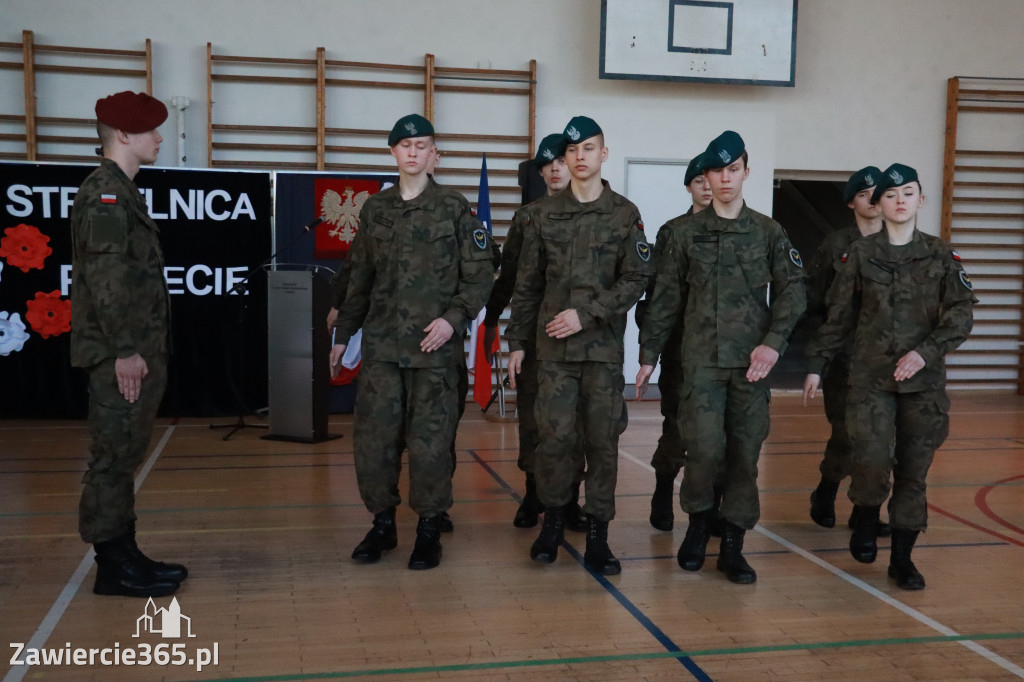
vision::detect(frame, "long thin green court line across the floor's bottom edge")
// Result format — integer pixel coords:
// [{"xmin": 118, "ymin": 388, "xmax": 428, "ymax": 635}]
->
[{"xmin": 178, "ymin": 632, "xmax": 1024, "ymax": 682}]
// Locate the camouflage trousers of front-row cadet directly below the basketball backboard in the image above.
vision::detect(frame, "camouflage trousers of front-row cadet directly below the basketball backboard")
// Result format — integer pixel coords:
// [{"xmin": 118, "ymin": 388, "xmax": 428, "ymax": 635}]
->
[{"xmin": 679, "ymin": 367, "xmax": 771, "ymax": 529}]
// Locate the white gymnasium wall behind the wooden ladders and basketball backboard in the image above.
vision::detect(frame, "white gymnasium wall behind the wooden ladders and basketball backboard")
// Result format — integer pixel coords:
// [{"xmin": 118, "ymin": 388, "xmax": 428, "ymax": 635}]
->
[{"xmin": 0, "ymin": 0, "xmax": 1024, "ymax": 231}]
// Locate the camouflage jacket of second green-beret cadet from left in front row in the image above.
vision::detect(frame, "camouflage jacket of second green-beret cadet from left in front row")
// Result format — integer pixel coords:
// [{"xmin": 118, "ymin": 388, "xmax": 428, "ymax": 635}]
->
[{"xmin": 506, "ymin": 182, "xmax": 653, "ymax": 363}]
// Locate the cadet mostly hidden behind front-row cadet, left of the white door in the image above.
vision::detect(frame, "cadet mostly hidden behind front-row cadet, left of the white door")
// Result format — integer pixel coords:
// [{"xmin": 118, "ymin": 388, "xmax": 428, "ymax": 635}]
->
[{"xmin": 483, "ymin": 133, "xmax": 588, "ymax": 531}]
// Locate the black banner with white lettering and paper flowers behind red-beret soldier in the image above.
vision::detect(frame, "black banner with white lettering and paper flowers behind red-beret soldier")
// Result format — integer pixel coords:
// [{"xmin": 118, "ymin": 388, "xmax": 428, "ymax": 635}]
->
[{"xmin": 0, "ymin": 163, "xmax": 271, "ymax": 418}]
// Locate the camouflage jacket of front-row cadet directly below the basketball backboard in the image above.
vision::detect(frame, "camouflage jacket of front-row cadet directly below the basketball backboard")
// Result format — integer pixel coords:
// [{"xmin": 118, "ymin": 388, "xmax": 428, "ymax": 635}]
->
[{"xmin": 640, "ymin": 205, "xmax": 807, "ymax": 368}]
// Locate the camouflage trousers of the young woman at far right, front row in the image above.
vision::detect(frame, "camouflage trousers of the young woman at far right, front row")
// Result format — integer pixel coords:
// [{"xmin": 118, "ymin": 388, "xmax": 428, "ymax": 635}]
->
[{"xmin": 847, "ymin": 387, "xmax": 949, "ymax": 530}]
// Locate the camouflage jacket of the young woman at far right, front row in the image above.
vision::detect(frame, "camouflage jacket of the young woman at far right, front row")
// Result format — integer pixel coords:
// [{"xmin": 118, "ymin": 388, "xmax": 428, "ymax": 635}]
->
[{"xmin": 808, "ymin": 229, "xmax": 976, "ymax": 393}]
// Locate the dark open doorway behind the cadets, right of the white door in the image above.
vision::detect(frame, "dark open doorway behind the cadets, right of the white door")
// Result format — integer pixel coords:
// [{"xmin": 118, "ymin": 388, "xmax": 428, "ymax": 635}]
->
[{"xmin": 771, "ymin": 180, "xmax": 853, "ymax": 389}]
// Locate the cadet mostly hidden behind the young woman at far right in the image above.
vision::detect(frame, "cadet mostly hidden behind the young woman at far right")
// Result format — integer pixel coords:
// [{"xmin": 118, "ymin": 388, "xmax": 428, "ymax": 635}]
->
[{"xmin": 804, "ymin": 166, "xmax": 890, "ymax": 536}]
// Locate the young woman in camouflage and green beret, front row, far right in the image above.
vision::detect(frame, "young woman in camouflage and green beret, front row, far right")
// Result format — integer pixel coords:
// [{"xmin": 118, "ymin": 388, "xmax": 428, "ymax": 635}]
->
[{"xmin": 808, "ymin": 164, "xmax": 976, "ymax": 590}]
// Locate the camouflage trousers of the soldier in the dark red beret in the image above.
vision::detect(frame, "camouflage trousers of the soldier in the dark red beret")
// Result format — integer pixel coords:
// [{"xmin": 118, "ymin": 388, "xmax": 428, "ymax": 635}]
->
[{"xmin": 78, "ymin": 357, "xmax": 167, "ymax": 544}]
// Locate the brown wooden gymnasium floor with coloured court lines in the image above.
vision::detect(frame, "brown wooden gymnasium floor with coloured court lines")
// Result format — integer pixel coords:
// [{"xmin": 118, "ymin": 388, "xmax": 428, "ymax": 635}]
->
[{"xmin": 0, "ymin": 393, "xmax": 1024, "ymax": 682}]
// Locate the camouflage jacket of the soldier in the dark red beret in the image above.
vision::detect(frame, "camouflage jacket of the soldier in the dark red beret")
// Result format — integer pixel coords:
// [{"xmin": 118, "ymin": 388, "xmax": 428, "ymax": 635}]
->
[{"xmin": 71, "ymin": 159, "xmax": 170, "ymax": 367}]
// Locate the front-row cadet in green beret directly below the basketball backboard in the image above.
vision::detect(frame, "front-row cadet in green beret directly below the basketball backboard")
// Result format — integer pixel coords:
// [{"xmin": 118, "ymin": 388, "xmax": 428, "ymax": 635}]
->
[{"xmin": 637, "ymin": 131, "xmax": 806, "ymax": 584}]
